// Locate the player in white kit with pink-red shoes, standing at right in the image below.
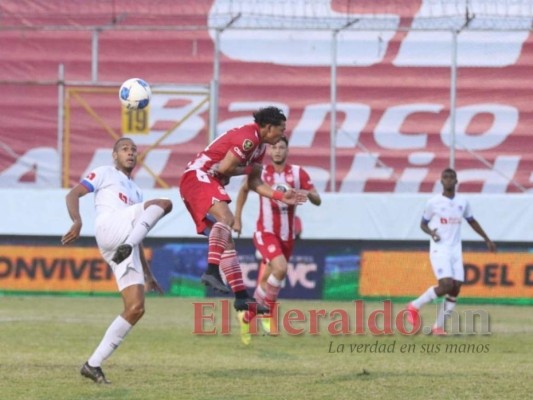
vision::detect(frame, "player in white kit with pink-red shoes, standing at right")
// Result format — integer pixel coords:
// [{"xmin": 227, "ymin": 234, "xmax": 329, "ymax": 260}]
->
[{"xmin": 407, "ymin": 168, "xmax": 496, "ymax": 335}]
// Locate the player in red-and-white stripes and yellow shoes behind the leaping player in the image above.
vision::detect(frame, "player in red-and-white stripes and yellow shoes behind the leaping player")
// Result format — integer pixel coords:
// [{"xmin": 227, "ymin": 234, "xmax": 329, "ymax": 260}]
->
[{"xmin": 233, "ymin": 136, "xmax": 322, "ymax": 344}]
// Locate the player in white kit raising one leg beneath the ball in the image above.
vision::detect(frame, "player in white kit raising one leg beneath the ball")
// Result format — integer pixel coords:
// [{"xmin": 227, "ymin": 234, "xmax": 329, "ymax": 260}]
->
[{"xmin": 61, "ymin": 138, "xmax": 172, "ymax": 383}]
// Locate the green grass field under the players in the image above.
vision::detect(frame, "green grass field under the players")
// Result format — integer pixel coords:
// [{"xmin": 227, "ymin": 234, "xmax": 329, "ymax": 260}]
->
[{"xmin": 0, "ymin": 296, "xmax": 533, "ymax": 400}]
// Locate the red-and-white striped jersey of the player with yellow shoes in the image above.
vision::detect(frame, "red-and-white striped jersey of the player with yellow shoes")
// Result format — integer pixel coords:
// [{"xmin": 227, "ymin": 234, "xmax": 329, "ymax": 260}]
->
[{"xmin": 257, "ymin": 164, "xmax": 314, "ymax": 241}]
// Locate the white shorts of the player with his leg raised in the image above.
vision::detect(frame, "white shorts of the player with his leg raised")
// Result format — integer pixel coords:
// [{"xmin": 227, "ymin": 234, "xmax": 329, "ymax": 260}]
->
[{"xmin": 95, "ymin": 203, "xmax": 144, "ymax": 292}]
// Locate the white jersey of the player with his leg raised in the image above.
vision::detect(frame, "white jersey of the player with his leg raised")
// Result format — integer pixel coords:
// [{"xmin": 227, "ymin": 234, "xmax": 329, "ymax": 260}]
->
[{"xmin": 81, "ymin": 166, "xmax": 143, "ymax": 220}]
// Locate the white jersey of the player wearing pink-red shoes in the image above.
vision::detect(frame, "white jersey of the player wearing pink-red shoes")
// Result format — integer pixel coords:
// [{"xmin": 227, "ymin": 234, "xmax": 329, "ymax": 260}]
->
[{"xmin": 422, "ymin": 194, "xmax": 473, "ymax": 251}]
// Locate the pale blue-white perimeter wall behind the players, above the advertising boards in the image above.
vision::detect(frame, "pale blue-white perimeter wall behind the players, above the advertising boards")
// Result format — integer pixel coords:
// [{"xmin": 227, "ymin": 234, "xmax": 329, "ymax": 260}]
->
[{"xmin": 0, "ymin": 189, "xmax": 533, "ymax": 242}]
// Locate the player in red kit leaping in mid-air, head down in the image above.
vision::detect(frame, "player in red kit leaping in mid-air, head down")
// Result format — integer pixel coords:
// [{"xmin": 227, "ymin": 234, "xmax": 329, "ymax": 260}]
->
[{"xmin": 180, "ymin": 107, "xmax": 307, "ymax": 313}]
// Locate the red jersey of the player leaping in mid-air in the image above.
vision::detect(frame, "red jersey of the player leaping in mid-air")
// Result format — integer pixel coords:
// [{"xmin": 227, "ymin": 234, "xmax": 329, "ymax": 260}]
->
[{"xmin": 186, "ymin": 123, "xmax": 266, "ymax": 186}]
